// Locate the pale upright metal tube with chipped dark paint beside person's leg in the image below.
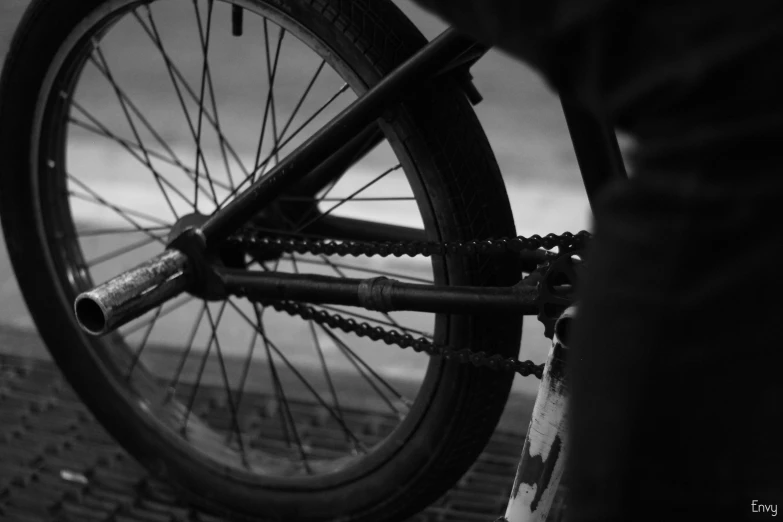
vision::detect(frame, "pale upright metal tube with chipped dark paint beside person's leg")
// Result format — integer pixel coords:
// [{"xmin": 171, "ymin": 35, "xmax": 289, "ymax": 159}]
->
[{"xmin": 498, "ymin": 307, "xmax": 576, "ymax": 522}]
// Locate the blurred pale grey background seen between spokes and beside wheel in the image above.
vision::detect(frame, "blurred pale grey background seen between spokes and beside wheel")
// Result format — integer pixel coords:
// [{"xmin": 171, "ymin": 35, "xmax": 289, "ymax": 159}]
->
[{"xmin": 0, "ymin": 0, "xmax": 590, "ymax": 398}]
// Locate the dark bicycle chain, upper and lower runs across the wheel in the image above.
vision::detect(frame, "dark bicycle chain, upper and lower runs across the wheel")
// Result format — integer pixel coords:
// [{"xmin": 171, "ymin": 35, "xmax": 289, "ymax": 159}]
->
[{"xmin": 228, "ymin": 229, "xmax": 591, "ymax": 379}]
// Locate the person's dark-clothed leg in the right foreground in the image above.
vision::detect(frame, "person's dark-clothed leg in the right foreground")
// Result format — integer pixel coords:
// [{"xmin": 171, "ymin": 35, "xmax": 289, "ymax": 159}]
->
[{"xmin": 410, "ymin": 0, "xmax": 783, "ymax": 522}]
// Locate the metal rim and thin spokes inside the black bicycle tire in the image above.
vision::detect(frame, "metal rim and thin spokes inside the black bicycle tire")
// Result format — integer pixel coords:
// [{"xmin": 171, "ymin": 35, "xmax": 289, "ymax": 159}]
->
[{"xmin": 35, "ymin": 1, "xmax": 460, "ymax": 487}]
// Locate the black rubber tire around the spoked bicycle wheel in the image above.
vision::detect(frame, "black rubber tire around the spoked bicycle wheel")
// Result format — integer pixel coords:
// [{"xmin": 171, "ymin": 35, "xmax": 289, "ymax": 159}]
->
[{"xmin": 0, "ymin": 0, "xmax": 522, "ymax": 521}]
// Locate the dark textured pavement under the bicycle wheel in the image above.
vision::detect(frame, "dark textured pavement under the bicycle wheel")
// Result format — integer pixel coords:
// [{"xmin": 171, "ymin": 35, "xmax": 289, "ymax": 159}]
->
[{"xmin": 0, "ymin": 329, "xmax": 564, "ymax": 522}]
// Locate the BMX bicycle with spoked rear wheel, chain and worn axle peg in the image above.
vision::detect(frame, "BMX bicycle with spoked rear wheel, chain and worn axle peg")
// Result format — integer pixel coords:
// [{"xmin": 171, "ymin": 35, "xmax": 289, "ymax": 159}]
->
[{"xmin": 0, "ymin": 0, "xmax": 625, "ymax": 521}]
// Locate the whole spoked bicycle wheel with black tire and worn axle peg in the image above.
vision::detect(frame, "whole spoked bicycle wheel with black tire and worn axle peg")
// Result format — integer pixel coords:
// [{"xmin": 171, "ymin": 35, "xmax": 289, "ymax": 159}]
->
[{"xmin": 0, "ymin": 0, "xmax": 521, "ymax": 521}]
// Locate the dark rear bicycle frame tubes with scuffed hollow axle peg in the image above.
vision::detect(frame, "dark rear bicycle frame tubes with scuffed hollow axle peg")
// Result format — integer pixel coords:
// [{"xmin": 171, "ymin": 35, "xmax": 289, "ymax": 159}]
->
[{"xmin": 74, "ymin": 29, "xmax": 625, "ymax": 335}]
